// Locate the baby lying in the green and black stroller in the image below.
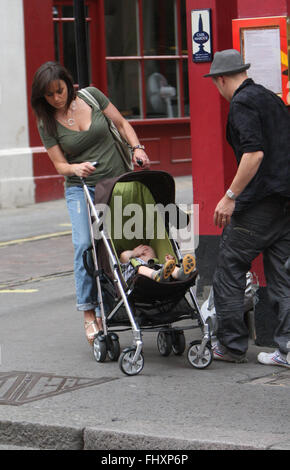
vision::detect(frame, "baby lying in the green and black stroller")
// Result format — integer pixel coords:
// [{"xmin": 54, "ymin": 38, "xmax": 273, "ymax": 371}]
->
[{"xmin": 120, "ymin": 245, "xmax": 195, "ymax": 282}]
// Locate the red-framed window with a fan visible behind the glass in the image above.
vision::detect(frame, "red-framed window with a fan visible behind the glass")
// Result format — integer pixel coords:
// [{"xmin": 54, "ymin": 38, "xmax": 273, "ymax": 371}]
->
[{"xmin": 104, "ymin": 0, "xmax": 189, "ymax": 119}]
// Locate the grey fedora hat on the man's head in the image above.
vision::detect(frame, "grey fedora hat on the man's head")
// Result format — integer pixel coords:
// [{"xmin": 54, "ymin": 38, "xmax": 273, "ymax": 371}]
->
[{"xmin": 204, "ymin": 49, "xmax": 251, "ymax": 77}]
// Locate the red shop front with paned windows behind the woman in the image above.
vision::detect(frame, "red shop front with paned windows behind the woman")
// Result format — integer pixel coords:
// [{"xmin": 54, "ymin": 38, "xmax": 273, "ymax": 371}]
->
[{"xmin": 23, "ymin": 0, "xmax": 191, "ymax": 202}]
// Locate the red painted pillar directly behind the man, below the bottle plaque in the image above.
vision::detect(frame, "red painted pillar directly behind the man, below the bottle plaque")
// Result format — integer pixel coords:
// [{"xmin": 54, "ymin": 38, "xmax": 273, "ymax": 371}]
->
[{"xmin": 186, "ymin": 0, "xmax": 237, "ymax": 235}]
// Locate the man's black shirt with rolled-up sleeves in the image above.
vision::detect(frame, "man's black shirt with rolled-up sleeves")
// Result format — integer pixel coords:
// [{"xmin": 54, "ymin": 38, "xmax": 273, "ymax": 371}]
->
[{"xmin": 227, "ymin": 78, "xmax": 290, "ymax": 211}]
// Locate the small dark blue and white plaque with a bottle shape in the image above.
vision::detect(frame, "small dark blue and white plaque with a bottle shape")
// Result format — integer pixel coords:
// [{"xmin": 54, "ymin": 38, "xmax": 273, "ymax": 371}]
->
[{"xmin": 191, "ymin": 8, "xmax": 212, "ymax": 62}]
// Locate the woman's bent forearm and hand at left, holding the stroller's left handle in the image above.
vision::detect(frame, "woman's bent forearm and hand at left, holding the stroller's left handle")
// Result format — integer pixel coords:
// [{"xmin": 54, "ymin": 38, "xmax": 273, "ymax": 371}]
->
[{"xmin": 47, "ymin": 145, "xmax": 95, "ymax": 178}]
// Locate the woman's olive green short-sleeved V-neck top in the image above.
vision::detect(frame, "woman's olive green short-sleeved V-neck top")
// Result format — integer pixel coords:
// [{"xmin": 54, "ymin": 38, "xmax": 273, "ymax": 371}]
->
[{"xmin": 38, "ymin": 87, "xmax": 126, "ymax": 187}]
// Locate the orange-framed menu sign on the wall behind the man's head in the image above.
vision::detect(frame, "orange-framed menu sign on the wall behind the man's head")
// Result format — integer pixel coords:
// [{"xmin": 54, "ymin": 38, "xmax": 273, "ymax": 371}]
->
[{"xmin": 233, "ymin": 16, "xmax": 290, "ymax": 105}]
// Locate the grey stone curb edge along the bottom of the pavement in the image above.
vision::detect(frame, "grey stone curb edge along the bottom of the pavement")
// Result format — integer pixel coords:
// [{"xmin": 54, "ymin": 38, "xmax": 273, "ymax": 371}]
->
[{"xmin": 0, "ymin": 421, "xmax": 274, "ymax": 451}]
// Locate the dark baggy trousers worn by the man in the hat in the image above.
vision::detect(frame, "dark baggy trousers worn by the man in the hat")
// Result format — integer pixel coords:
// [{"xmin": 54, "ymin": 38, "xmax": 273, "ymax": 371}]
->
[{"xmin": 213, "ymin": 196, "xmax": 290, "ymax": 358}]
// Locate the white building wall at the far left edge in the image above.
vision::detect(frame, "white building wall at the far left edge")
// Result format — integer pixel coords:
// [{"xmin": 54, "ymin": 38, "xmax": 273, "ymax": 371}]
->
[{"xmin": 0, "ymin": 0, "xmax": 34, "ymax": 208}]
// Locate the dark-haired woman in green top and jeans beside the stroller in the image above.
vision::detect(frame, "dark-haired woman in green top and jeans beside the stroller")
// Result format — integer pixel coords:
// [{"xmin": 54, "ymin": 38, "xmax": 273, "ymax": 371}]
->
[{"xmin": 31, "ymin": 62, "xmax": 150, "ymax": 344}]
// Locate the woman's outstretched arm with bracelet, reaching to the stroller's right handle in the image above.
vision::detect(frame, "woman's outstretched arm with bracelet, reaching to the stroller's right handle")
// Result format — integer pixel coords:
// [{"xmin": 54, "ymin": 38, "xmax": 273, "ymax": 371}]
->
[{"xmin": 103, "ymin": 103, "xmax": 150, "ymax": 168}]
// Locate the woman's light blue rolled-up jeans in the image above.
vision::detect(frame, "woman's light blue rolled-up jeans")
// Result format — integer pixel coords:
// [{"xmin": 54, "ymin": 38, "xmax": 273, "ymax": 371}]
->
[{"xmin": 65, "ymin": 186, "xmax": 100, "ymax": 316}]
